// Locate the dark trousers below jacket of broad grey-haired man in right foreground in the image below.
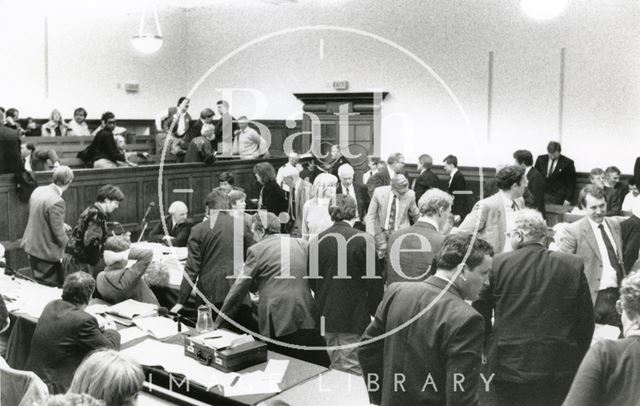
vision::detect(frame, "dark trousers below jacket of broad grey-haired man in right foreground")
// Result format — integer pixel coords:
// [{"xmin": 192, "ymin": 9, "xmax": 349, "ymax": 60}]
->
[{"xmin": 495, "ymin": 378, "xmax": 572, "ymax": 406}]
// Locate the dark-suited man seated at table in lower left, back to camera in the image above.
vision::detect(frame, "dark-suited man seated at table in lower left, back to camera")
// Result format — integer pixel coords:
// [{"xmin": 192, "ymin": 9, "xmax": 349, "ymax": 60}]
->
[{"xmin": 26, "ymin": 271, "xmax": 120, "ymax": 393}]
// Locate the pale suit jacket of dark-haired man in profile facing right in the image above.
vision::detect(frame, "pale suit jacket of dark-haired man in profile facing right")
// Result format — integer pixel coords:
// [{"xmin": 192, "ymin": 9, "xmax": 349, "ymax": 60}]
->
[{"xmin": 459, "ymin": 192, "xmax": 524, "ymax": 253}]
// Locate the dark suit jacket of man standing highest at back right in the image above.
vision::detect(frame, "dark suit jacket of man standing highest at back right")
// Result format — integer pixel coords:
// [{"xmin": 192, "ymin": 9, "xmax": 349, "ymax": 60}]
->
[{"xmin": 534, "ymin": 155, "xmax": 576, "ymax": 204}]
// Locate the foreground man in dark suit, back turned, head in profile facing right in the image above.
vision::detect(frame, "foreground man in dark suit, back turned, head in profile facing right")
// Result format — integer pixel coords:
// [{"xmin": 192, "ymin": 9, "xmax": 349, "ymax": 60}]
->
[{"xmin": 358, "ymin": 234, "xmax": 493, "ymax": 406}]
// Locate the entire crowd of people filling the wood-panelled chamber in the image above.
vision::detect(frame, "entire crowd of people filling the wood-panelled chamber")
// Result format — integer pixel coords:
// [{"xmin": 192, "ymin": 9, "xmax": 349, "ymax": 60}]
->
[{"xmin": 2, "ymin": 99, "xmax": 640, "ymax": 405}]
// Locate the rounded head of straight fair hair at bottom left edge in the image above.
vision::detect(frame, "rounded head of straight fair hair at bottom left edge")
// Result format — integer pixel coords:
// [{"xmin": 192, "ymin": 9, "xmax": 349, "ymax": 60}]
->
[{"xmin": 68, "ymin": 350, "xmax": 144, "ymax": 406}]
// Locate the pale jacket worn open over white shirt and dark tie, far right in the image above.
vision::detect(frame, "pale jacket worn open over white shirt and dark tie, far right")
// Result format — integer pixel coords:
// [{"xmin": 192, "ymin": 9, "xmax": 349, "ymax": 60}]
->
[{"xmin": 560, "ymin": 217, "xmax": 625, "ymax": 303}]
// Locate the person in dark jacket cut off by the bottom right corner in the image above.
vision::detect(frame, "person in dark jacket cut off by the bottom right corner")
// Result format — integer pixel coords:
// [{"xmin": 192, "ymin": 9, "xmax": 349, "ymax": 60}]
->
[{"xmin": 563, "ymin": 272, "xmax": 640, "ymax": 406}]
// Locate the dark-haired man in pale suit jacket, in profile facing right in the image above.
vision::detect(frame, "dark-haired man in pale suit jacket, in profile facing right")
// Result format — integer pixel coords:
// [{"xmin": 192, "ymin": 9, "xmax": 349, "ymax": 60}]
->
[{"xmin": 459, "ymin": 165, "xmax": 528, "ymax": 253}]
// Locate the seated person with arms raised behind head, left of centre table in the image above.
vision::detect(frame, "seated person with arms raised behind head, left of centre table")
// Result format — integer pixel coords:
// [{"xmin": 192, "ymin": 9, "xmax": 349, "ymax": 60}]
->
[{"xmin": 96, "ymin": 236, "xmax": 158, "ymax": 305}]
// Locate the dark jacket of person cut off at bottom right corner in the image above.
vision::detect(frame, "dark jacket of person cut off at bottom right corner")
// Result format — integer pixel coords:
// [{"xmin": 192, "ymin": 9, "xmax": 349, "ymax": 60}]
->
[{"xmin": 563, "ymin": 336, "xmax": 640, "ymax": 406}]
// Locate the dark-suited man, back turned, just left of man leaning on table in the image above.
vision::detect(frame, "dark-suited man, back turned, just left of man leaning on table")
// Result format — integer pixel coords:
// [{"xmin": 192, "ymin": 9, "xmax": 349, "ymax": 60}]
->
[{"xmin": 171, "ymin": 190, "xmax": 255, "ymax": 327}]
